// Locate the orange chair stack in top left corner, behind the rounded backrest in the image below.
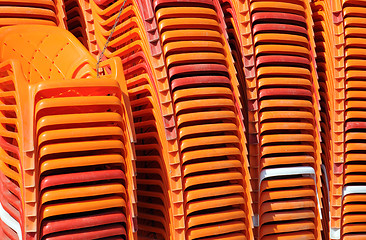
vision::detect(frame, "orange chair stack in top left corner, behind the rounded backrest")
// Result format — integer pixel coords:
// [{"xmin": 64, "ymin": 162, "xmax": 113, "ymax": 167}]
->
[{"xmin": 0, "ymin": 0, "xmax": 65, "ymax": 28}]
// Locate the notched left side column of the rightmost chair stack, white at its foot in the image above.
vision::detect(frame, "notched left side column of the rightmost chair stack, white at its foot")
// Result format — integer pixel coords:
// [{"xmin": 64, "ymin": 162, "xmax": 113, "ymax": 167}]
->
[{"xmin": 329, "ymin": 0, "xmax": 346, "ymax": 239}]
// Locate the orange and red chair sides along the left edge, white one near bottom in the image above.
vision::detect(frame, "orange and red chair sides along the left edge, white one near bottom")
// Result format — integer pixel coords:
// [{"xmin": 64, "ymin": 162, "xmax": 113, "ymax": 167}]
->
[{"xmin": 0, "ymin": 61, "xmax": 25, "ymax": 240}]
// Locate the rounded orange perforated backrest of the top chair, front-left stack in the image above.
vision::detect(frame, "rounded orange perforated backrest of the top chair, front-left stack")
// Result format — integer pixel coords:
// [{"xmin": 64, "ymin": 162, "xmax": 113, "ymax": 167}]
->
[{"xmin": 0, "ymin": 25, "xmax": 96, "ymax": 83}]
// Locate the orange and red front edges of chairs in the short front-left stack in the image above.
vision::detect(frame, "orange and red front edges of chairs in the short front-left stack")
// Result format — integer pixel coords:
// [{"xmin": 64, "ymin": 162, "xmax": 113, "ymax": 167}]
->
[{"xmin": 35, "ymin": 79, "xmax": 132, "ymax": 239}]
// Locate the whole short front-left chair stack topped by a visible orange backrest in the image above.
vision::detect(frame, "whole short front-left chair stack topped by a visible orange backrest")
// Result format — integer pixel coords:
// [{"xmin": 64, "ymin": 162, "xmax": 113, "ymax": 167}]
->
[{"xmin": 0, "ymin": 25, "xmax": 136, "ymax": 239}]
